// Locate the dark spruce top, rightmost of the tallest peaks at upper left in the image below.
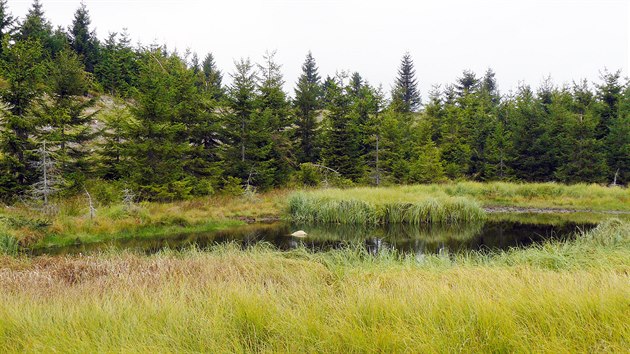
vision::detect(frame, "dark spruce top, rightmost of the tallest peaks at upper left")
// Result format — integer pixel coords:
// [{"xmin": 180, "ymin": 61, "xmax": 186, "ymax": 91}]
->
[{"xmin": 68, "ymin": 2, "xmax": 99, "ymax": 73}]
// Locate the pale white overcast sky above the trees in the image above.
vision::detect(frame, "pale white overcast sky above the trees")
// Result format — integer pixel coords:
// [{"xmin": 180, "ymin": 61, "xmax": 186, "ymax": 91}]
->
[{"xmin": 8, "ymin": 0, "xmax": 630, "ymax": 99}]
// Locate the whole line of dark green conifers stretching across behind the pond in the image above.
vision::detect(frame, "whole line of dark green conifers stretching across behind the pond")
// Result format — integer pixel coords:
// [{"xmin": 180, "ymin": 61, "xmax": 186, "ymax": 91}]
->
[{"xmin": 0, "ymin": 0, "xmax": 630, "ymax": 201}]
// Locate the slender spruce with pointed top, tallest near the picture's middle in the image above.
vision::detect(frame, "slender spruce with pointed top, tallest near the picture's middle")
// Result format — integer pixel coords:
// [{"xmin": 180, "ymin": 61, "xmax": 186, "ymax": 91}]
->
[{"xmin": 294, "ymin": 52, "xmax": 322, "ymax": 163}]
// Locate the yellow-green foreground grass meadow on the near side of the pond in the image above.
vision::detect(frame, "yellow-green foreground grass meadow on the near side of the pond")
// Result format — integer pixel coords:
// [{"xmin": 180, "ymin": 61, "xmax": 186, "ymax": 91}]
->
[{"xmin": 0, "ymin": 220, "xmax": 630, "ymax": 353}]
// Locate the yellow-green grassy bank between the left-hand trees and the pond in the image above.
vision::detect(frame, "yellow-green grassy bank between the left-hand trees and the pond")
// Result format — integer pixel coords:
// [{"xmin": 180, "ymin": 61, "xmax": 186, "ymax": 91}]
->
[{"xmin": 0, "ymin": 191, "xmax": 286, "ymax": 247}]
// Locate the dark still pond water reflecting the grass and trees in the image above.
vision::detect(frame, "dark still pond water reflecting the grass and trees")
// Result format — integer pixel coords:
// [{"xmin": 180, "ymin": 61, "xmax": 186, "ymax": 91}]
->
[{"xmin": 33, "ymin": 221, "xmax": 594, "ymax": 254}]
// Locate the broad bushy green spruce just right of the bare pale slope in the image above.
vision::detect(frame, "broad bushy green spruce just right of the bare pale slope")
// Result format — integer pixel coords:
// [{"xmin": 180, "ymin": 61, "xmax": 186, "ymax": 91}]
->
[{"xmin": 123, "ymin": 48, "xmax": 194, "ymax": 201}]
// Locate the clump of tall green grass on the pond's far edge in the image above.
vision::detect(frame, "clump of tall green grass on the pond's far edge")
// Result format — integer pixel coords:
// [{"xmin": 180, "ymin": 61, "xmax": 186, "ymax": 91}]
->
[{"xmin": 287, "ymin": 192, "xmax": 486, "ymax": 225}]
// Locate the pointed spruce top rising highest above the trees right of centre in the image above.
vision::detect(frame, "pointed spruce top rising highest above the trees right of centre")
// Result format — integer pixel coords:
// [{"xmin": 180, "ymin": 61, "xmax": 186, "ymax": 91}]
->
[{"xmin": 392, "ymin": 53, "xmax": 420, "ymax": 113}]
